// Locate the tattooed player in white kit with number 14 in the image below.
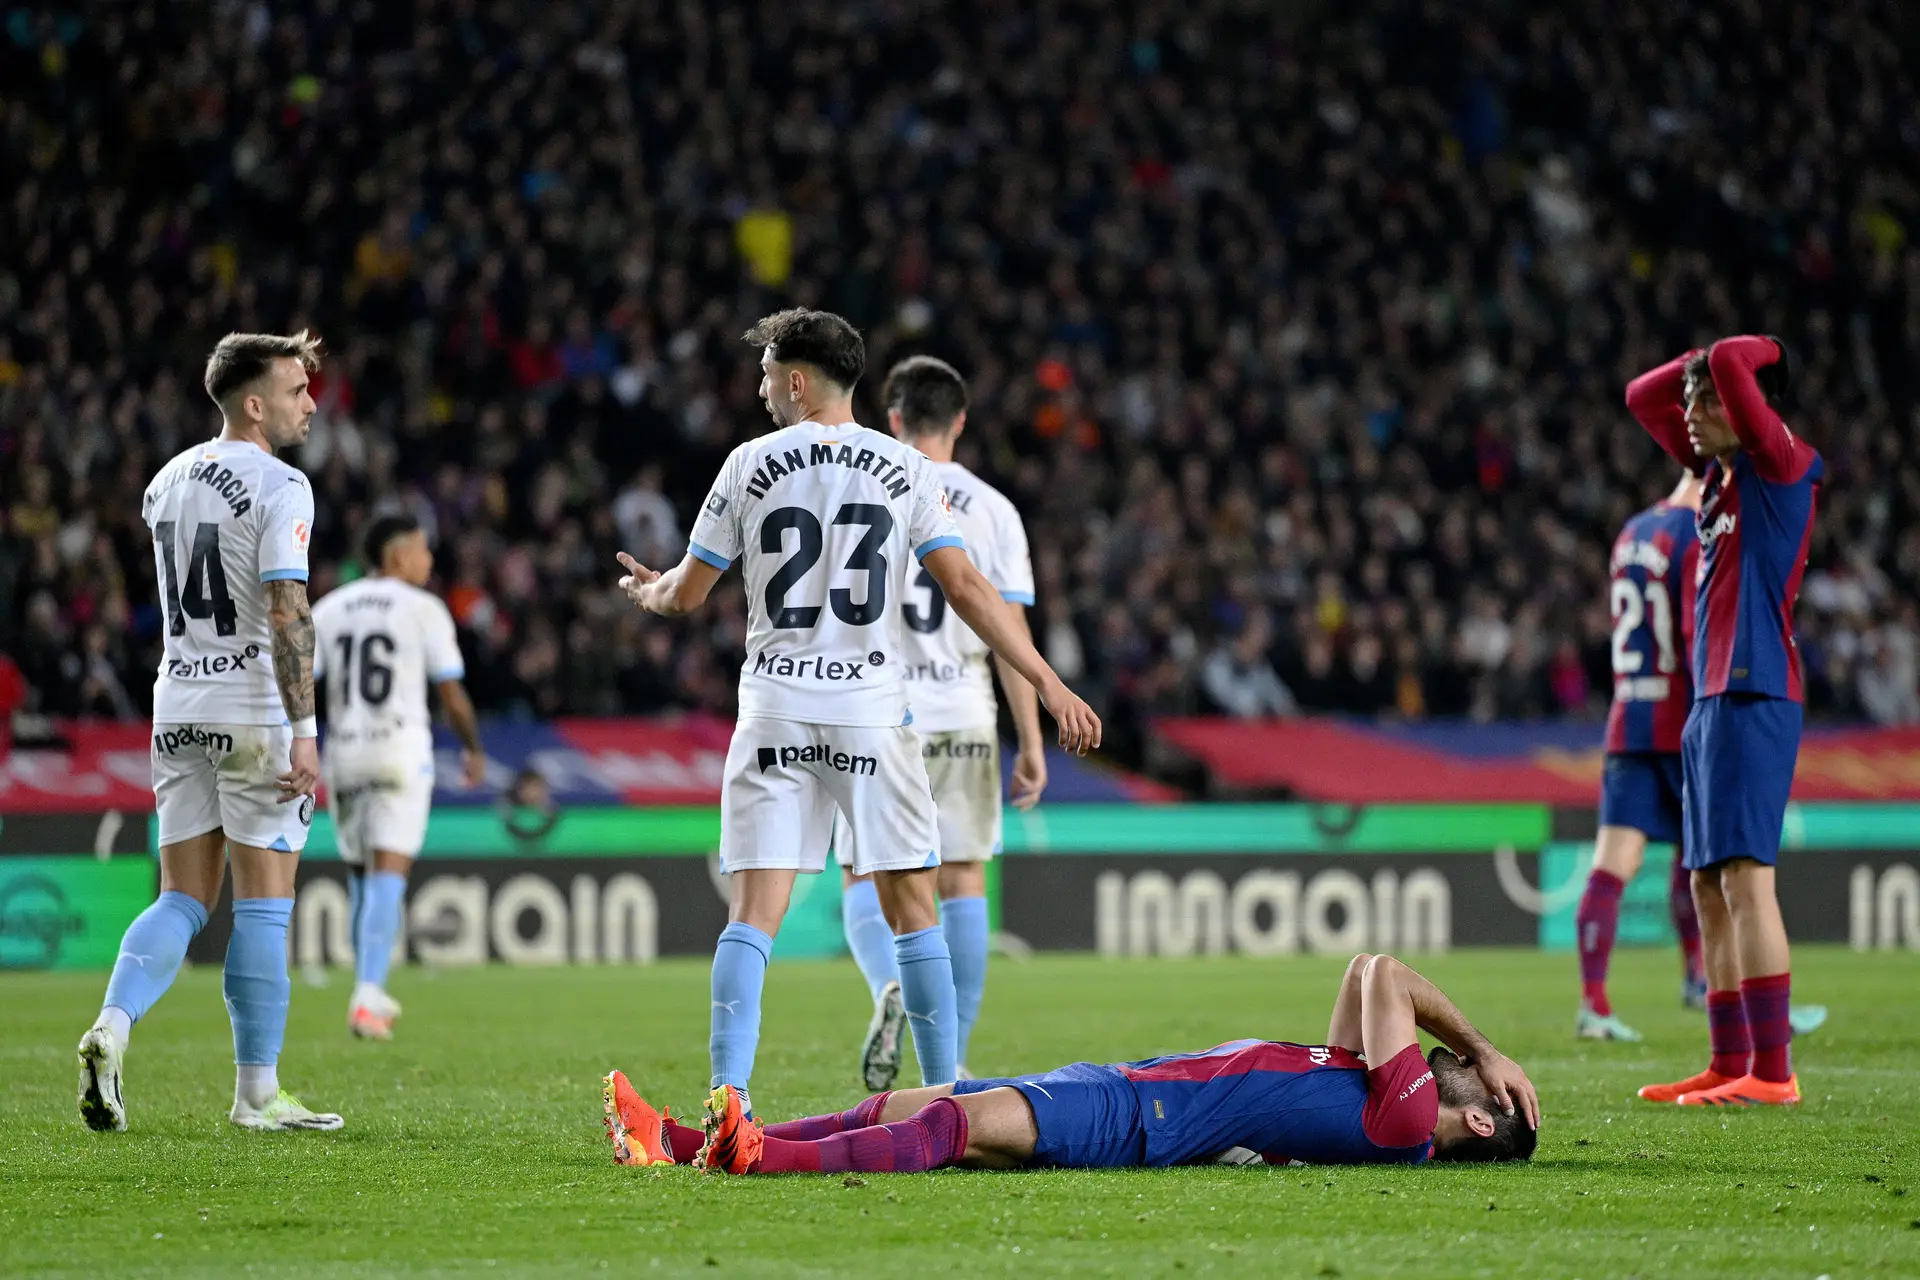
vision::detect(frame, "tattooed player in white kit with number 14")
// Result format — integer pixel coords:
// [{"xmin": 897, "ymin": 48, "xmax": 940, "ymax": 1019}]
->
[{"xmin": 79, "ymin": 330, "xmax": 342, "ymax": 1130}]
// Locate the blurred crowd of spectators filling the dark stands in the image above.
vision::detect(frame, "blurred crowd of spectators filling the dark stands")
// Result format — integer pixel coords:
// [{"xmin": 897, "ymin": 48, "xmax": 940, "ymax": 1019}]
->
[{"xmin": 0, "ymin": 0, "xmax": 1920, "ymax": 752}]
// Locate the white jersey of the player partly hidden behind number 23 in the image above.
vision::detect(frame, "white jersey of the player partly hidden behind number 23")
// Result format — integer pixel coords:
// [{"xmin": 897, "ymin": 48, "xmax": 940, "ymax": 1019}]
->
[{"xmin": 900, "ymin": 462, "xmax": 1033, "ymax": 733}]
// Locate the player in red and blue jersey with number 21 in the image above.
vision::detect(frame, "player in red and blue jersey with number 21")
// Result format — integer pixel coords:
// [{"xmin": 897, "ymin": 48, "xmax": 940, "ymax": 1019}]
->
[{"xmin": 1574, "ymin": 472, "xmax": 1707, "ymax": 1040}]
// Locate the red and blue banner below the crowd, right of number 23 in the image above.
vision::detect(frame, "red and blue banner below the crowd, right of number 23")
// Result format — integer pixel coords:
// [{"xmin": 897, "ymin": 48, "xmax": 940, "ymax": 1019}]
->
[{"xmin": 1154, "ymin": 716, "xmax": 1920, "ymax": 806}]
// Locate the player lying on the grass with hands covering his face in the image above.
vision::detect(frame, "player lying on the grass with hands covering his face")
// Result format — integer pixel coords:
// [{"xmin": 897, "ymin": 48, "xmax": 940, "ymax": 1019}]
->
[{"xmin": 605, "ymin": 956, "xmax": 1540, "ymax": 1173}]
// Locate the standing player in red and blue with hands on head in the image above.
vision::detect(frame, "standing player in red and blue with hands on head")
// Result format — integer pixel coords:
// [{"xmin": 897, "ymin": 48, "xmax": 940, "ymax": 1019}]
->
[{"xmin": 1626, "ymin": 336, "xmax": 1826, "ymax": 1105}]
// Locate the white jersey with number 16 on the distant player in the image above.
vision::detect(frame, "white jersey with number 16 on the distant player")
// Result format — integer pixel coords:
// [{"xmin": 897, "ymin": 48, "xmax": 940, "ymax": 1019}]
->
[{"xmin": 313, "ymin": 578, "xmax": 467, "ymax": 768}]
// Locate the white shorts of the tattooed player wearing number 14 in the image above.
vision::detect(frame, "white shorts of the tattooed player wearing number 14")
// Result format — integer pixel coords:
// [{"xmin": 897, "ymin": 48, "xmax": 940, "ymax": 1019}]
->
[{"xmin": 152, "ymin": 723, "xmax": 313, "ymax": 854}]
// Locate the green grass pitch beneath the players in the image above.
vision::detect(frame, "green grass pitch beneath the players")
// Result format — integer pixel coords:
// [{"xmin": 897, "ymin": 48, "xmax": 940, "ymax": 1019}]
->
[{"xmin": 0, "ymin": 948, "xmax": 1920, "ymax": 1280}]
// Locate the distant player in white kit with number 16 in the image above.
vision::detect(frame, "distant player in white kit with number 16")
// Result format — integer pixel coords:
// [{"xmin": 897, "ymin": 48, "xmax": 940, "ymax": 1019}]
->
[{"xmin": 313, "ymin": 516, "xmax": 486, "ymax": 1040}]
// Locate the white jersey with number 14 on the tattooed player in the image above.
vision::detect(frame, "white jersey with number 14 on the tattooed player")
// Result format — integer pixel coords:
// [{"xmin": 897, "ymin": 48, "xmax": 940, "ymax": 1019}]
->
[{"xmin": 140, "ymin": 439, "xmax": 313, "ymax": 725}]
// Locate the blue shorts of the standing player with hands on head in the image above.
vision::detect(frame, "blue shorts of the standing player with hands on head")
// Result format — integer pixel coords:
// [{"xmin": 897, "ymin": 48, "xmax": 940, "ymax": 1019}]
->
[{"xmin": 1680, "ymin": 693, "xmax": 1801, "ymax": 871}]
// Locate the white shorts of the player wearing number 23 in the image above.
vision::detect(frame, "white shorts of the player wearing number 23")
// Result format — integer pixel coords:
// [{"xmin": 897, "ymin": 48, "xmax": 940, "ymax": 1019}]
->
[{"xmin": 720, "ymin": 718, "xmax": 941, "ymax": 875}]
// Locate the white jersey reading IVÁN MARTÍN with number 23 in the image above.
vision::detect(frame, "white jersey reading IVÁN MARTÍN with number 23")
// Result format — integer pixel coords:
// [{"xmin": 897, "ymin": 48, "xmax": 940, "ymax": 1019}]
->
[{"xmin": 689, "ymin": 422, "xmax": 964, "ymax": 725}]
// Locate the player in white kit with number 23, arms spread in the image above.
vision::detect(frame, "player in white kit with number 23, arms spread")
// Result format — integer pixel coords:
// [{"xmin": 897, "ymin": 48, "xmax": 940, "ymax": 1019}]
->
[{"xmin": 620, "ymin": 309, "xmax": 1100, "ymax": 1098}]
